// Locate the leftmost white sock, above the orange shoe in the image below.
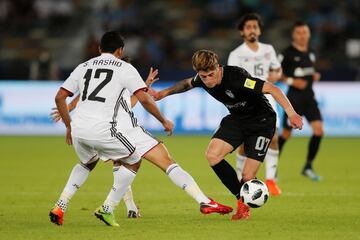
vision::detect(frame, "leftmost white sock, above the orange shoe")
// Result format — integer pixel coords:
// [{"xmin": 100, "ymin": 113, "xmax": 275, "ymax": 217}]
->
[{"xmin": 56, "ymin": 163, "xmax": 90, "ymax": 212}]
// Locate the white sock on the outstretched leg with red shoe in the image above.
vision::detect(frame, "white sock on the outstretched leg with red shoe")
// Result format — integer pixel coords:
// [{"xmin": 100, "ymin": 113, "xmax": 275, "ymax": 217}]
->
[{"xmin": 166, "ymin": 163, "xmax": 210, "ymax": 204}]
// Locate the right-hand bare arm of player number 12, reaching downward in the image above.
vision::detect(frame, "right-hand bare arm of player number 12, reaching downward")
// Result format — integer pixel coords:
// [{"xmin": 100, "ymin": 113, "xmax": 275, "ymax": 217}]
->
[{"xmin": 135, "ymin": 90, "xmax": 174, "ymax": 135}]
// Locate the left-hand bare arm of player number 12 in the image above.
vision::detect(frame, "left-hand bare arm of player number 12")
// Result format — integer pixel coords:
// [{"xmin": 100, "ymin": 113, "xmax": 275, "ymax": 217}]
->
[{"xmin": 55, "ymin": 88, "xmax": 72, "ymax": 145}]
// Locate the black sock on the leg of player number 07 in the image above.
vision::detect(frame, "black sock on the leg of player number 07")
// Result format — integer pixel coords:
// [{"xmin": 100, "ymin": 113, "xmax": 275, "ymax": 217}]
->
[{"xmin": 212, "ymin": 159, "xmax": 242, "ymax": 199}]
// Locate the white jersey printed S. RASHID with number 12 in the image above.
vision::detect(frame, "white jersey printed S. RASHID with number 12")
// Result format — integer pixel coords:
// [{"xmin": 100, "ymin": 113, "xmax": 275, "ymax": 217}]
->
[{"xmin": 62, "ymin": 53, "xmax": 146, "ymax": 140}]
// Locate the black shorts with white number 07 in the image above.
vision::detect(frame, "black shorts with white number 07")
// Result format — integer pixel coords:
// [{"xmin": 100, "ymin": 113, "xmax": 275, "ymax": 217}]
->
[{"xmin": 212, "ymin": 114, "xmax": 276, "ymax": 162}]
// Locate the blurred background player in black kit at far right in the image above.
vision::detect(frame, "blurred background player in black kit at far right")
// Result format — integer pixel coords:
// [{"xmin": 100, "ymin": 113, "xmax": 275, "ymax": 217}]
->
[{"xmin": 279, "ymin": 21, "xmax": 324, "ymax": 181}]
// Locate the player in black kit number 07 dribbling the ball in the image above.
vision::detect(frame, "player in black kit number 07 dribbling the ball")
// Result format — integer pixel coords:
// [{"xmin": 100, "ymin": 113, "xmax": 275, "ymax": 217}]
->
[{"xmin": 152, "ymin": 50, "xmax": 303, "ymax": 220}]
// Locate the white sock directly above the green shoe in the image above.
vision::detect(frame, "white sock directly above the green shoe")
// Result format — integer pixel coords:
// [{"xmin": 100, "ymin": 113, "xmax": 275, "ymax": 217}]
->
[{"xmin": 102, "ymin": 166, "xmax": 136, "ymax": 213}]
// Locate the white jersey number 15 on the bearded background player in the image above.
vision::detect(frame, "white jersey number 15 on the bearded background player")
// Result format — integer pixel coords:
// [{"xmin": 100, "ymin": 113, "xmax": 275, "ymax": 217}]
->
[{"xmin": 228, "ymin": 43, "xmax": 281, "ymax": 81}]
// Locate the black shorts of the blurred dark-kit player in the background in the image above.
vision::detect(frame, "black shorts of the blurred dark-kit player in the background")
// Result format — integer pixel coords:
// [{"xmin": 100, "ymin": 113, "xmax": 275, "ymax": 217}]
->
[{"xmin": 283, "ymin": 92, "xmax": 322, "ymax": 129}]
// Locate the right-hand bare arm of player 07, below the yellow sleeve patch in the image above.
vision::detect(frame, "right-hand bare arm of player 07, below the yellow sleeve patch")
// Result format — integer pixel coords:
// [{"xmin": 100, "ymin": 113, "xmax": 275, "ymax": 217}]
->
[{"xmin": 262, "ymin": 82, "xmax": 303, "ymax": 130}]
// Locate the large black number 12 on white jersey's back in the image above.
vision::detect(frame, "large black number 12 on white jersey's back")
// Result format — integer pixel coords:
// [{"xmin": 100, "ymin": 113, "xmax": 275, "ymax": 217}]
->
[{"xmin": 81, "ymin": 68, "xmax": 114, "ymax": 102}]
